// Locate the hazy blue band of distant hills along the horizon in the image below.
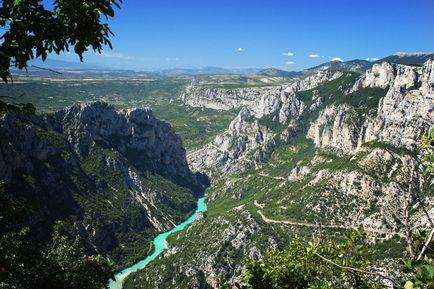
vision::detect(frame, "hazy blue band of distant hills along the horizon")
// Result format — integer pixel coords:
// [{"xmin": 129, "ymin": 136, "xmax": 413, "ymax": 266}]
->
[{"xmin": 13, "ymin": 52, "xmax": 434, "ymax": 78}]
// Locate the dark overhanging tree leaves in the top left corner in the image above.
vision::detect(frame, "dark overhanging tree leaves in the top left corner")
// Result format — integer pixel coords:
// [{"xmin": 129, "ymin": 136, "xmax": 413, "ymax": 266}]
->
[{"xmin": 0, "ymin": 0, "xmax": 122, "ymax": 82}]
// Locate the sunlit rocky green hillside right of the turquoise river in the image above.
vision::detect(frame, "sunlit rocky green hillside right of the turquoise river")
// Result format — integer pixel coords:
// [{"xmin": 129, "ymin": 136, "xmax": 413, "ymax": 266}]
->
[{"xmin": 125, "ymin": 60, "xmax": 434, "ymax": 289}]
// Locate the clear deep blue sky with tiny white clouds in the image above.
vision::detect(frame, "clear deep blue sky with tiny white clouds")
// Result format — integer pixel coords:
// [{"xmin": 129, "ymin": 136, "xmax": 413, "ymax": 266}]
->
[{"xmin": 52, "ymin": 0, "xmax": 434, "ymax": 70}]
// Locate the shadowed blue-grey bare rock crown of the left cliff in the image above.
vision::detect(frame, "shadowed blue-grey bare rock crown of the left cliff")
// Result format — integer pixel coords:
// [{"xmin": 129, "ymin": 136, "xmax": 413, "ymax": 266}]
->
[{"xmin": 53, "ymin": 102, "xmax": 197, "ymax": 188}]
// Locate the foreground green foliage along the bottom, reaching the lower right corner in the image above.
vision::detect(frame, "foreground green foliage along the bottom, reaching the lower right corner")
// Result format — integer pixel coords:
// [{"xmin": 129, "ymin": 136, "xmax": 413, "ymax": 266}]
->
[{"xmin": 219, "ymin": 230, "xmax": 434, "ymax": 289}]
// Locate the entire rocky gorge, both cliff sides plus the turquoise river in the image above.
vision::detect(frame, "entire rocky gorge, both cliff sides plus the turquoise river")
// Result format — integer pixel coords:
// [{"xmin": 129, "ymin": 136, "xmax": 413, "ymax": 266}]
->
[{"xmin": 0, "ymin": 53, "xmax": 434, "ymax": 289}]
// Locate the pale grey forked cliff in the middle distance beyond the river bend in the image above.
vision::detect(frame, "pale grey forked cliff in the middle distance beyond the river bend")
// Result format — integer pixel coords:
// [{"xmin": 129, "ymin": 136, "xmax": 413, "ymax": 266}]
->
[{"xmin": 186, "ymin": 71, "xmax": 343, "ymax": 177}]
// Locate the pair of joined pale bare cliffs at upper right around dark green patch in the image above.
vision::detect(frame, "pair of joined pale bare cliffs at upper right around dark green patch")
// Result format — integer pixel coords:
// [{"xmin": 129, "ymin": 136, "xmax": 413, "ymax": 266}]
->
[{"xmin": 307, "ymin": 60, "xmax": 434, "ymax": 153}]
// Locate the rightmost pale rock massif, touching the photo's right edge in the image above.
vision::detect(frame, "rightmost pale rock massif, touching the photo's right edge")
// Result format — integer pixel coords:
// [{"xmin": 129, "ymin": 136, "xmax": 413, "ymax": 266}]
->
[{"xmin": 361, "ymin": 59, "xmax": 434, "ymax": 150}]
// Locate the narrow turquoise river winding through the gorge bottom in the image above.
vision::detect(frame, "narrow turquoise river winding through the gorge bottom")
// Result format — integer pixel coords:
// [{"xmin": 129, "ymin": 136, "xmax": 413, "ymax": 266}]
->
[{"xmin": 109, "ymin": 197, "xmax": 206, "ymax": 289}]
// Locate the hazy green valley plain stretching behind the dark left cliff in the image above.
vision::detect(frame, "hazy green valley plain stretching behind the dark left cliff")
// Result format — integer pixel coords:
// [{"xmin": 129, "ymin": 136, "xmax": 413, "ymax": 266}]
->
[{"xmin": 0, "ymin": 77, "xmax": 234, "ymax": 150}]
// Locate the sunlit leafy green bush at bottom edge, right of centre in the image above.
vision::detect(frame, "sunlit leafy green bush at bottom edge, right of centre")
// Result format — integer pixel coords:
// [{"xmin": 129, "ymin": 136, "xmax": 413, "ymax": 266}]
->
[{"xmin": 224, "ymin": 231, "xmax": 383, "ymax": 289}]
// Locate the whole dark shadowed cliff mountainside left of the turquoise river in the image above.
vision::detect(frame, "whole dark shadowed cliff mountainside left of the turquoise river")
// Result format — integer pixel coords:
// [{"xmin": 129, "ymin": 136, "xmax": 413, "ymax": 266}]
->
[{"xmin": 0, "ymin": 103, "xmax": 201, "ymax": 262}]
